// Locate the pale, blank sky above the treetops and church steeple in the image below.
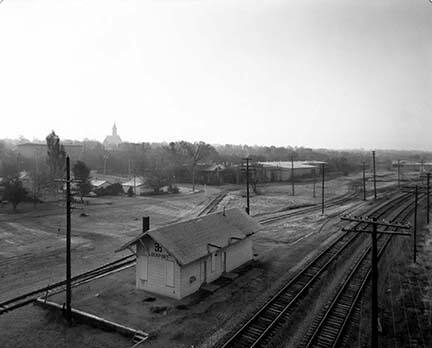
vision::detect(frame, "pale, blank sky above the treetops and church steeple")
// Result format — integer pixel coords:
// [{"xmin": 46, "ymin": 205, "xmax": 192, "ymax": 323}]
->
[{"xmin": 0, "ymin": 0, "xmax": 432, "ymax": 150}]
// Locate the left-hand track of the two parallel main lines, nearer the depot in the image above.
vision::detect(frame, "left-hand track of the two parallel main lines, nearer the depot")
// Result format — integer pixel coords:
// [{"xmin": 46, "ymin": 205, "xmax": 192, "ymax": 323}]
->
[{"xmin": 221, "ymin": 194, "xmax": 409, "ymax": 348}]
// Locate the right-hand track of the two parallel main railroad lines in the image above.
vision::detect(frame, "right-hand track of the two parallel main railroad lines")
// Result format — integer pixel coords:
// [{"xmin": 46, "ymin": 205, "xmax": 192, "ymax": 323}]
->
[{"xmin": 299, "ymin": 196, "xmax": 414, "ymax": 348}]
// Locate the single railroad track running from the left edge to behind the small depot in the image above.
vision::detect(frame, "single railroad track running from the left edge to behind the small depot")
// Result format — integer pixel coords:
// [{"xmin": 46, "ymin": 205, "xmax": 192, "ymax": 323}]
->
[{"xmin": 0, "ymin": 255, "xmax": 136, "ymax": 315}]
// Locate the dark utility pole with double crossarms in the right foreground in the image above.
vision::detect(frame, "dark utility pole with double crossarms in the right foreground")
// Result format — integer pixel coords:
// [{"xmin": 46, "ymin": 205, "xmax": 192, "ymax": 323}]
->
[{"xmin": 341, "ymin": 216, "xmax": 411, "ymax": 348}]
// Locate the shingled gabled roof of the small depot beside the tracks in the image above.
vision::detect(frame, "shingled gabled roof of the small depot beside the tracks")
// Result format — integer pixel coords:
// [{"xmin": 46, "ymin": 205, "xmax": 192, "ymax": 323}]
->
[{"xmin": 118, "ymin": 208, "xmax": 261, "ymax": 265}]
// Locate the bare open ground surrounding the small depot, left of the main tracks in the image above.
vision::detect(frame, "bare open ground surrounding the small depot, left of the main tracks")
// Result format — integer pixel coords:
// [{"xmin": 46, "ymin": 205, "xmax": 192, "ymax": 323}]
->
[{"xmin": 0, "ymin": 175, "xmax": 402, "ymax": 347}]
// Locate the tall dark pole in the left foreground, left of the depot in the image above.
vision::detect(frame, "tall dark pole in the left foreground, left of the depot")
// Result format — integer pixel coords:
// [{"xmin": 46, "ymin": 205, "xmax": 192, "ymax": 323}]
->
[{"xmin": 66, "ymin": 156, "xmax": 72, "ymax": 324}]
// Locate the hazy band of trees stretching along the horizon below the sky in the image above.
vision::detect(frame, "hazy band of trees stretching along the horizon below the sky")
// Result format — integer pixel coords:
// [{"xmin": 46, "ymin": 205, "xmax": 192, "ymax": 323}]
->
[{"xmin": 0, "ymin": 131, "xmax": 404, "ymax": 208}]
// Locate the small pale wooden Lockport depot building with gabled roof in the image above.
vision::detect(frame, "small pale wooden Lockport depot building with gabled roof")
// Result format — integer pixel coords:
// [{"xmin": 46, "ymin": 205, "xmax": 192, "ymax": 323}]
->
[{"xmin": 118, "ymin": 208, "xmax": 261, "ymax": 299}]
